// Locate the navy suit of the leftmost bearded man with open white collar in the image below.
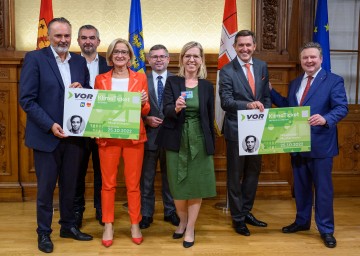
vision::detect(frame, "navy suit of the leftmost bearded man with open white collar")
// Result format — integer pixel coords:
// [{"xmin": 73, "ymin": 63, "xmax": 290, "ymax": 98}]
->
[{"xmin": 19, "ymin": 47, "xmax": 90, "ymax": 235}]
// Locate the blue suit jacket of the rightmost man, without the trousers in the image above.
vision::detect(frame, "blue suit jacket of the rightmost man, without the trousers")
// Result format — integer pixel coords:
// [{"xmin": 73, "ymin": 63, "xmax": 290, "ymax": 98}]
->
[{"xmin": 271, "ymin": 69, "xmax": 348, "ymax": 158}]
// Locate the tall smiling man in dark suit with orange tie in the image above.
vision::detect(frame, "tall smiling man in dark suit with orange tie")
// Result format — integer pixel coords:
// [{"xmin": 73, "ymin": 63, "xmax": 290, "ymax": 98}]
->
[{"xmin": 219, "ymin": 30, "xmax": 271, "ymax": 236}]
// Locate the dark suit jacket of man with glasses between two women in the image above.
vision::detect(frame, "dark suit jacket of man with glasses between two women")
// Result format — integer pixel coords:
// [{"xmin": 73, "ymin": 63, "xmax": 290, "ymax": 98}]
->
[{"xmin": 145, "ymin": 72, "xmax": 173, "ymax": 150}]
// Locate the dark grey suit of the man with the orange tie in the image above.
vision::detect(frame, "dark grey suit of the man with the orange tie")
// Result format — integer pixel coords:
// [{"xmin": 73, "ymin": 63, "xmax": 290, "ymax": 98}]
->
[{"xmin": 219, "ymin": 58, "xmax": 271, "ymax": 222}]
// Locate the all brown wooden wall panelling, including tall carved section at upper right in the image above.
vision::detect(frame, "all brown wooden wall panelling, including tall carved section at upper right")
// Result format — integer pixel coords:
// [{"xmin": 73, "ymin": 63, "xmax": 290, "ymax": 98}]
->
[{"xmin": 0, "ymin": 0, "xmax": 360, "ymax": 201}]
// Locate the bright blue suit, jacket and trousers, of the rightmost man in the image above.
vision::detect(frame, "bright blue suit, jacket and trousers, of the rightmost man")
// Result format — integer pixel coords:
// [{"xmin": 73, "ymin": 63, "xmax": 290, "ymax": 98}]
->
[{"xmin": 271, "ymin": 69, "xmax": 348, "ymax": 234}]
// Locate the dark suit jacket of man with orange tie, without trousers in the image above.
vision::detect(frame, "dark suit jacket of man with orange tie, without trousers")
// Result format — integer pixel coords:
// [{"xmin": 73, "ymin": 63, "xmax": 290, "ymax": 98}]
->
[{"xmin": 219, "ymin": 58, "xmax": 271, "ymax": 141}]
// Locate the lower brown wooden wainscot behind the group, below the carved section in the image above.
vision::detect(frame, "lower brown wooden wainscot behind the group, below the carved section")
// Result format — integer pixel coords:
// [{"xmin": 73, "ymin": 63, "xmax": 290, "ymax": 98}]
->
[{"xmin": 0, "ymin": 53, "xmax": 360, "ymax": 201}]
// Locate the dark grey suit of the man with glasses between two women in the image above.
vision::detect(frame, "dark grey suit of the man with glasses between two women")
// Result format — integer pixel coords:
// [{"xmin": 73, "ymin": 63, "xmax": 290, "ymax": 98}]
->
[{"xmin": 140, "ymin": 72, "xmax": 176, "ymax": 217}]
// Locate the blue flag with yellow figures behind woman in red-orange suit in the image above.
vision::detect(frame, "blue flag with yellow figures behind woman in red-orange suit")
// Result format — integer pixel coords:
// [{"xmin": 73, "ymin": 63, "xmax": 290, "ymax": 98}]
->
[{"xmin": 129, "ymin": 0, "xmax": 146, "ymax": 73}]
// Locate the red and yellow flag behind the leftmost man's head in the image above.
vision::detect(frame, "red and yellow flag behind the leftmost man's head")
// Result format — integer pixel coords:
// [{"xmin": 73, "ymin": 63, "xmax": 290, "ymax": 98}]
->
[{"xmin": 36, "ymin": 0, "xmax": 53, "ymax": 50}]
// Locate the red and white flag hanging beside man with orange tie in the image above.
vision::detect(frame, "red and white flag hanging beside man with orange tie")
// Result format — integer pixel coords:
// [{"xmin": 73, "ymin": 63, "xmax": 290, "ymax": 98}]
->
[{"xmin": 215, "ymin": 0, "xmax": 238, "ymax": 135}]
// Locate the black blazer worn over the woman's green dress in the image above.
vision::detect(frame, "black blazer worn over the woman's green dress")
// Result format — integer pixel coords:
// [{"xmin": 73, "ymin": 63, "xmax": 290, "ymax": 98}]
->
[{"xmin": 155, "ymin": 76, "xmax": 215, "ymax": 155}]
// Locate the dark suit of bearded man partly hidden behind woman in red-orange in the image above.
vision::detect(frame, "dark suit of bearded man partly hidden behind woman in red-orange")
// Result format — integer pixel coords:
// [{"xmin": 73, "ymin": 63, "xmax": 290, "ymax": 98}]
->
[{"xmin": 74, "ymin": 55, "xmax": 112, "ymax": 216}]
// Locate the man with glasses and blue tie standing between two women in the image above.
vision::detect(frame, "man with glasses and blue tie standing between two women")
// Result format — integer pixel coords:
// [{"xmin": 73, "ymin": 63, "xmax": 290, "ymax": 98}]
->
[{"xmin": 140, "ymin": 44, "xmax": 180, "ymax": 229}]
